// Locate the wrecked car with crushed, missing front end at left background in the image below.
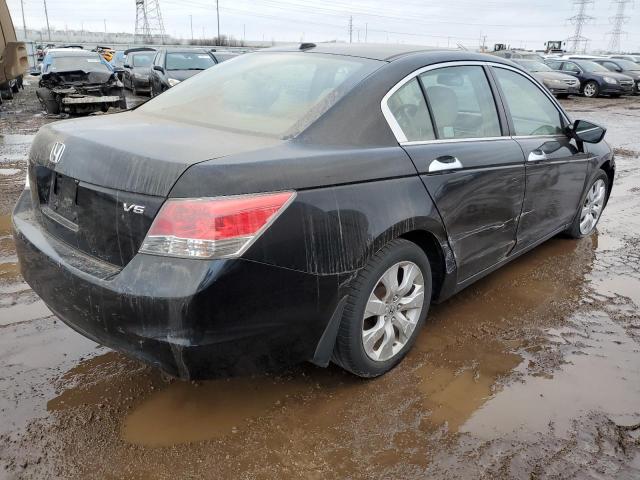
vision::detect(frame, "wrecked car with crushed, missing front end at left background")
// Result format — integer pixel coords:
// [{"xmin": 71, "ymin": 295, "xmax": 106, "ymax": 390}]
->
[{"xmin": 36, "ymin": 49, "xmax": 127, "ymax": 115}]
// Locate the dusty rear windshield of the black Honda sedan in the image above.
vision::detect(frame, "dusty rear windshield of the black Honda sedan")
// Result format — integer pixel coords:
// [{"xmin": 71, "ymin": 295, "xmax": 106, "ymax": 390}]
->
[{"xmin": 137, "ymin": 52, "xmax": 384, "ymax": 138}]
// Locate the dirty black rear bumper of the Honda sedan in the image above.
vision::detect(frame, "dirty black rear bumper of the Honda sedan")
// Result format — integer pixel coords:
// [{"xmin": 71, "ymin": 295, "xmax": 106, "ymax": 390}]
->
[{"xmin": 13, "ymin": 194, "xmax": 340, "ymax": 379}]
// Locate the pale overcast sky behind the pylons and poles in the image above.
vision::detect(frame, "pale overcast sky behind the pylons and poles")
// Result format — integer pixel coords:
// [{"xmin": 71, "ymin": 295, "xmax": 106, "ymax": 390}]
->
[{"xmin": 7, "ymin": 0, "xmax": 640, "ymax": 51}]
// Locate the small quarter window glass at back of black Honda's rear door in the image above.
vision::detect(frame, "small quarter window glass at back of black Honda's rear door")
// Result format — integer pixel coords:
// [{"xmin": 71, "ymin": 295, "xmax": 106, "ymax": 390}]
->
[{"xmin": 387, "ymin": 78, "xmax": 436, "ymax": 142}]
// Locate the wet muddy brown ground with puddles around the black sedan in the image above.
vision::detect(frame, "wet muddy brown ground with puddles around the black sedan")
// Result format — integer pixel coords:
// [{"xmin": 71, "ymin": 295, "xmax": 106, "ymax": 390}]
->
[{"xmin": 0, "ymin": 77, "xmax": 640, "ymax": 479}]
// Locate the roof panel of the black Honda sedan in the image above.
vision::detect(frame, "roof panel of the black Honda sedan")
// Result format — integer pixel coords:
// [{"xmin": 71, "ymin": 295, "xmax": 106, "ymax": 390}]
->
[{"xmin": 256, "ymin": 43, "xmax": 509, "ymax": 64}]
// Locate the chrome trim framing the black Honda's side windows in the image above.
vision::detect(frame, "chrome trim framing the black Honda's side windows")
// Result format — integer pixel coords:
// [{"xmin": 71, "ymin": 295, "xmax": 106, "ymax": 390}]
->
[{"xmin": 380, "ymin": 60, "xmax": 571, "ymax": 146}]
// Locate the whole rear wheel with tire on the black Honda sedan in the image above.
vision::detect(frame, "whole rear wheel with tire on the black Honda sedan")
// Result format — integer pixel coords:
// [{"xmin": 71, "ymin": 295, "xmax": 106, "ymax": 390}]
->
[{"xmin": 333, "ymin": 239, "xmax": 432, "ymax": 378}]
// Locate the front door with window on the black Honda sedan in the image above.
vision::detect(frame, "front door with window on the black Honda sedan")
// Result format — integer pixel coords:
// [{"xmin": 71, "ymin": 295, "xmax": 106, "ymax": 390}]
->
[{"xmin": 492, "ymin": 65, "xmax": 588, "ymax": 249}]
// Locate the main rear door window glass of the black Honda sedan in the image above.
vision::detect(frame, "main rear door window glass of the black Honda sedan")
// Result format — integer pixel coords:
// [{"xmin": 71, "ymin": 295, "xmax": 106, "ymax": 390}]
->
[{"xmin": 420, "ymin": 66, "xmax": 502, "ymax": 139}]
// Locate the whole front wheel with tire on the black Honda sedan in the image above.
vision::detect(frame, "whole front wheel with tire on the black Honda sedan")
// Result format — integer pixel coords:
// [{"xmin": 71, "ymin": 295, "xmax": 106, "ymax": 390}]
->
[{"xmin": 565, "ymin": 169, "xmax": 610, "ymax": 238}]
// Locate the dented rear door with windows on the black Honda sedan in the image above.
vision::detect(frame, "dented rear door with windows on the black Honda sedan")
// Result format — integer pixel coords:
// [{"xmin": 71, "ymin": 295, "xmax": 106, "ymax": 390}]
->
[{"xmin": 383, "ymin": 62, "xmax": 524, "ymax": 282}]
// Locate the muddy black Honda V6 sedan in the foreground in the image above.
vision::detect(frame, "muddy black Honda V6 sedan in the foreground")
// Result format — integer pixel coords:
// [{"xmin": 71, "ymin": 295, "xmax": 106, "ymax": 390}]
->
[{"xmin": 13, "ymin": 44, "xmax": 615, "ymax": 378}]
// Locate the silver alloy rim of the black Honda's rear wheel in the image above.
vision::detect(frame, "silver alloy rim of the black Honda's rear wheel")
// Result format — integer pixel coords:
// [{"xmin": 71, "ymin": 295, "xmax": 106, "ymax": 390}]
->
[{"xmin": 362, "ymin": 262, "xmax": 425, "ymax": 362}]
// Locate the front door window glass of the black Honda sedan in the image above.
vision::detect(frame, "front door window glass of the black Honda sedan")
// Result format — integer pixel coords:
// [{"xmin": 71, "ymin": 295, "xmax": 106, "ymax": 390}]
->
[{"xmin": 493, "ymin": 68, "xmax": 564, "ymax": 136}]
